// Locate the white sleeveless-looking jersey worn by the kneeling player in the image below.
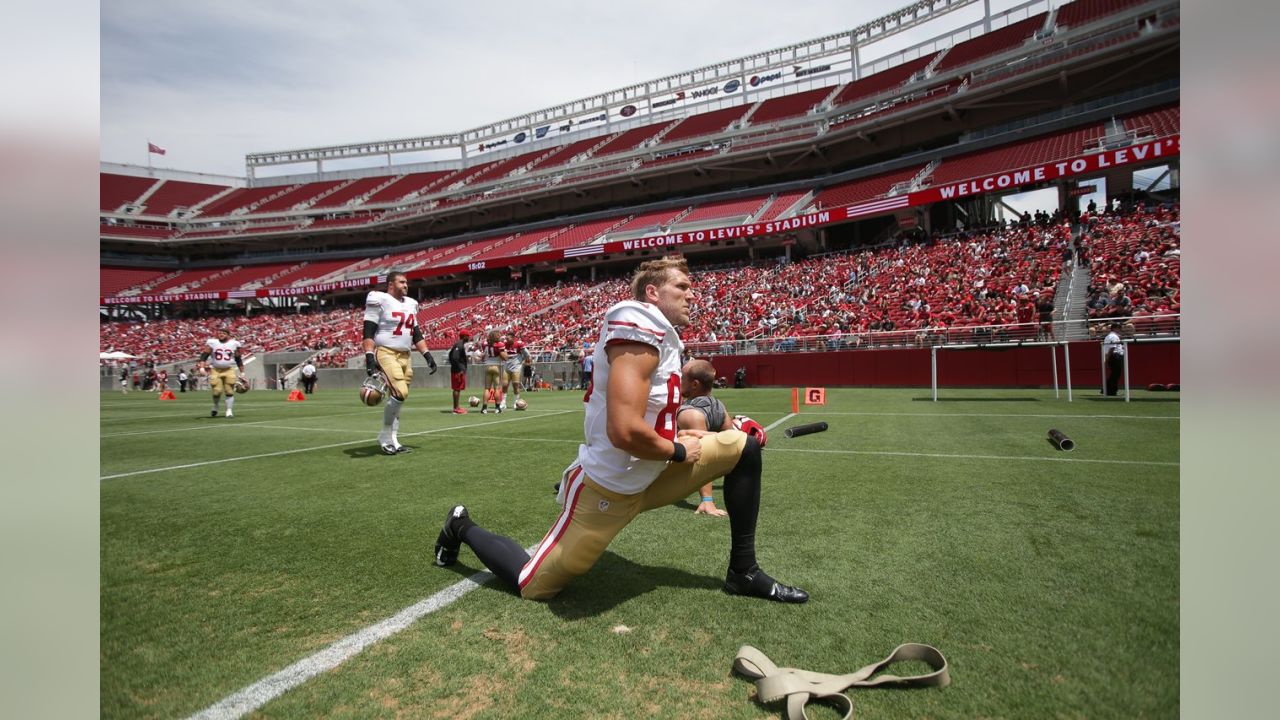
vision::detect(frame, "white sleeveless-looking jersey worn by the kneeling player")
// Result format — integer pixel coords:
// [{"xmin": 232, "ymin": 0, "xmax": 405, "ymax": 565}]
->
[{"xmin": 577, "ymin": 300, "xmax": 685, "ymax": 495}]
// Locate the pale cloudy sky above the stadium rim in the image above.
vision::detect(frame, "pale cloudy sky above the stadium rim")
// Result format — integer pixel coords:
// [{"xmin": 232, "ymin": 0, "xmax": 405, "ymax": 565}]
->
[{"xmin": 100, "ymin": 0, "xmax": 1039, "ymax": 176}]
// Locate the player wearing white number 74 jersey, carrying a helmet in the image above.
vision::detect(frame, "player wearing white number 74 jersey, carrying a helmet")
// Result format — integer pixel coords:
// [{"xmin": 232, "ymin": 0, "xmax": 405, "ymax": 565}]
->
[{"xmin": 361, "ymin": 270, "xmax": 436, "ymax": 455}]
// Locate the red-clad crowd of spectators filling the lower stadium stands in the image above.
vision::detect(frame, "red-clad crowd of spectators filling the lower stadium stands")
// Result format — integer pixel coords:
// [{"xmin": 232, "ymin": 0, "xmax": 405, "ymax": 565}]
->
[{"xmin": 100, "ymin": 205, "xmax": 1180, "ymax": 366}]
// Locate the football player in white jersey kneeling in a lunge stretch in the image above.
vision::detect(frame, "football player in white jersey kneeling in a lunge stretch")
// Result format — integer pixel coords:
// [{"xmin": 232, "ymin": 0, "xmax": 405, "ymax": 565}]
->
[{"xmin": 435, "ymin": 255, "xmax": 809, "ymax": 602}]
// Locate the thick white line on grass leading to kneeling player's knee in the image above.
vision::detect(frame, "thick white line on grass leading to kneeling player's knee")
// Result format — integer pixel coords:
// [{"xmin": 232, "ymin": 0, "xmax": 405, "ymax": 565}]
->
[{"xmin": 188, "ymin": 571, "xmax": 493, "ymax": 720}]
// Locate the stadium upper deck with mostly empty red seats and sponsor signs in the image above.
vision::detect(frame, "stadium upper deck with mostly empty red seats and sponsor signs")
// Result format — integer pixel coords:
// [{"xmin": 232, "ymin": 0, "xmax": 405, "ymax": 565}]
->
[{"xmin": 100, "ymin": 0, "xmax": 1179, "ymax": 297}]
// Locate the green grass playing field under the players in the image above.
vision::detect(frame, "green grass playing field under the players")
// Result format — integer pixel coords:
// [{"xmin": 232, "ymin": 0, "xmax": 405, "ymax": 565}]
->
[{"xmin": 100, "ymin": 389, "xmax": 1179, "ymax": 719}]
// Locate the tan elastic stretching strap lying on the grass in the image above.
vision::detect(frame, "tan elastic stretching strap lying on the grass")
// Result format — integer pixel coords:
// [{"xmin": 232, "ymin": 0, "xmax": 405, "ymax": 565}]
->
[{"xmin": 733, "ymin": 643, "xmax": 951, "ymax": 720}]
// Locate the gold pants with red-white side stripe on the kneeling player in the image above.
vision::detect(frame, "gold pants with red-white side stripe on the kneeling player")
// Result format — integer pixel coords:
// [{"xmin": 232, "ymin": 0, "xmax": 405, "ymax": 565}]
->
[{"xmin": 520, "ymin": 430, "xmax": 746, "ymax": 600}]
